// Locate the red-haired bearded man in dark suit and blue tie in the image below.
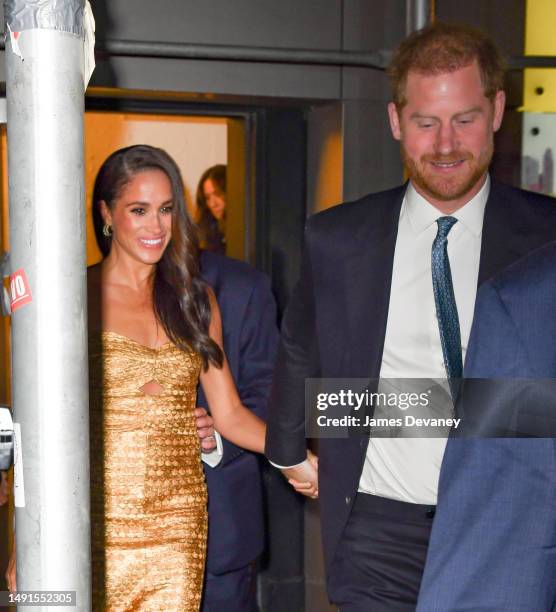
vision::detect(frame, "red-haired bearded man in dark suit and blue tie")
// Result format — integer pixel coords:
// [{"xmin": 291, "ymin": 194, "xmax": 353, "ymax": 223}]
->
[{"xmin": 266, "ymin": 23, "xmax": 556, "ymax": 612}]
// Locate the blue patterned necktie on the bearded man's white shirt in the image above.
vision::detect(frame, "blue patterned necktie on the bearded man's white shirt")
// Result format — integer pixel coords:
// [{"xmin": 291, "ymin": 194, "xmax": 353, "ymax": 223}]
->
[{"xmin": 431, "ymin": 217, "xmax": 463, "ymax": 401}]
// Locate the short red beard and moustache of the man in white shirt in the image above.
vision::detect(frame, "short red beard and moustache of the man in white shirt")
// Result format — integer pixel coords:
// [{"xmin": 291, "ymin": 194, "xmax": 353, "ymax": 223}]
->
[{"xmin": 401, "ymin": 143, "xmax": 493, "ymax": 202}]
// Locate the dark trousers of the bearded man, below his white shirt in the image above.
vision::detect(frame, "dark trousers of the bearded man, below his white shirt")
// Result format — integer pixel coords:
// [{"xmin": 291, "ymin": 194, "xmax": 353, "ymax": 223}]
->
[{"xmin": 328, "ymin": 493, "xmax": 434, "ymax": 612}]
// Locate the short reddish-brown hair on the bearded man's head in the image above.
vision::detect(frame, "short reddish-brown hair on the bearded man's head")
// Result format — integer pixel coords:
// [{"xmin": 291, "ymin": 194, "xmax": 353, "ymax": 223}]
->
[{"xmin": 388, "ymin": 22, "xmax": 505, "ymax": 110}]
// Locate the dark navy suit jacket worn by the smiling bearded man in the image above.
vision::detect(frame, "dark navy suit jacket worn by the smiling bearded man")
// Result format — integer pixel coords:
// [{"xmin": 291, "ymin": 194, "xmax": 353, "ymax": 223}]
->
[{"xmin": 266, "ymin": 181, "xmax": 556, "ymax": 568}]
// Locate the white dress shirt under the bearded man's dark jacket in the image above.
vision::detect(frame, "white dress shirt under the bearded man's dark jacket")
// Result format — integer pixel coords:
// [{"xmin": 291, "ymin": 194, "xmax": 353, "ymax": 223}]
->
[{"xmin": 359, "ymin": 177, "xmax": 490, "ymax": 505}]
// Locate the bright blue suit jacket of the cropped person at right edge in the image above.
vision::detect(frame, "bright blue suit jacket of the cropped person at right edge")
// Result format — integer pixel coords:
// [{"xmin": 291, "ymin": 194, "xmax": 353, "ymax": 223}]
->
[{"xmin": 418, "ymin": 243, "xmax": 556, "ymax": 612}]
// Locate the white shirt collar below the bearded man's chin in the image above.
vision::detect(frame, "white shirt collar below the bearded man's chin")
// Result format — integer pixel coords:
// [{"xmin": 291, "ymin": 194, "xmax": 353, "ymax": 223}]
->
[{"xmin": 403, "ymin": 174, "xmax": 490, "ymax": 236}]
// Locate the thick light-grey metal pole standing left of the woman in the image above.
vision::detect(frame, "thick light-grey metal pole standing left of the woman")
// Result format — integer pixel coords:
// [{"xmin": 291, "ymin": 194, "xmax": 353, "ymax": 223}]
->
[{"xmin": 4, "ymin": 0, "xmax": 91, "ymax": 610}]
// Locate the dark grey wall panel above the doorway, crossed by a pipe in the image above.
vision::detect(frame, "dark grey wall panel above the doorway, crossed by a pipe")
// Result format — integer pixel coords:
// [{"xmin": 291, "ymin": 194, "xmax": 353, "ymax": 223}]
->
[{"xmin": 86, "ymin": 0, "xmax": 342, "ymax": 98}]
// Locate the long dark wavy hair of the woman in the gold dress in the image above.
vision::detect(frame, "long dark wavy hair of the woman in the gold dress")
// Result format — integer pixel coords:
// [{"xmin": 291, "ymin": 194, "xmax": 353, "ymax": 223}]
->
[{"xmin": 93, "ymin": 145, "xmax": 223, "ymax": 369}]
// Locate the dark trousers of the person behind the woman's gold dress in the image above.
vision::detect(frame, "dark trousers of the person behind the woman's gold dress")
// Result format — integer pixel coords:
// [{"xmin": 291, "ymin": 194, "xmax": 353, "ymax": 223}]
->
[{"xmin": 201, "ymin": 564, "xmax": 259, "ymax": 612}]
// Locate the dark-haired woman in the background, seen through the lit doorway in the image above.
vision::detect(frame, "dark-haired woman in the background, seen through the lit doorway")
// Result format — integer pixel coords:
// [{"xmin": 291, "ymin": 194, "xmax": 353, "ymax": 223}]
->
[{"xmin": 197, "ymin": 164, "xmax": 226, "ymax": 255}]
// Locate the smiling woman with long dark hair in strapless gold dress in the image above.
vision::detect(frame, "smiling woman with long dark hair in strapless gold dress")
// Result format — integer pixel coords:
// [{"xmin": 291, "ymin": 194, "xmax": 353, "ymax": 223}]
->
[{"xmin": 88, "ymin": 145, "xmax": 264, "ymax": 611}]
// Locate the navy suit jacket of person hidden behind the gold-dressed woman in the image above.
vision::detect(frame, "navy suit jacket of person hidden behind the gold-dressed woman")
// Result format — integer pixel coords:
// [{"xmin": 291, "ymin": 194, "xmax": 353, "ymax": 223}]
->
[{"xmin": 198, "ymin": 252, "xmax": 278, "ymax": 574}]
